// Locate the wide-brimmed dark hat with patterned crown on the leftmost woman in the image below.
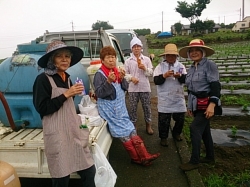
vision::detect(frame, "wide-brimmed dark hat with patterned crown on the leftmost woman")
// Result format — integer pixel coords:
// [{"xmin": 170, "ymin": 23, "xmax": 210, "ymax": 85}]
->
[{"xmin": 38, "ymin": 40, "xmax": 83, "ymax": 68}]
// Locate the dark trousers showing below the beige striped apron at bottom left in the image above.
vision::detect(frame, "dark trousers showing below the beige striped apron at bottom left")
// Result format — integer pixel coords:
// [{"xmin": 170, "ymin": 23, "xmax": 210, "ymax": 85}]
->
[{"xmin": 52, "ymin": 165, "xmax": 96, "ymax": 187}]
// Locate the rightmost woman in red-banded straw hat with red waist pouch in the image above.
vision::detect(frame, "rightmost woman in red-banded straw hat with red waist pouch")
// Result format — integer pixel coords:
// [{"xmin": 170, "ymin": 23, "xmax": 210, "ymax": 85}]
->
[{"xmin": 179, "ymin": 39, "xmax": 221, "ymax": 171}]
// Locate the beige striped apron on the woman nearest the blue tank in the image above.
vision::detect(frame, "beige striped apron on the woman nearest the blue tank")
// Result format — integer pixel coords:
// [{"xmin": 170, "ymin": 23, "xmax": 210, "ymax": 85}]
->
[{"xmin": 42, "ymin": 76, "xmax": 94, "ymax": 178}]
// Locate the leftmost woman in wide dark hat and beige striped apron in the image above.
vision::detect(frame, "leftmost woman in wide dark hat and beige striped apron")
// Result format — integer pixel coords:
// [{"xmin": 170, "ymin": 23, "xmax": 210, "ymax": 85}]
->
[{"xmin": 33, "ymin": 41, "xmax": 96, "ymax": 187}]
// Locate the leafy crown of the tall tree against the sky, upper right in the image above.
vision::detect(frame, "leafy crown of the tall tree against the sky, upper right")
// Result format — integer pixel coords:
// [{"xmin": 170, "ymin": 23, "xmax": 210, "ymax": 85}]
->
[{"xmin": 175, "ymin": 0, "xmax": 211, "ymax": 23}]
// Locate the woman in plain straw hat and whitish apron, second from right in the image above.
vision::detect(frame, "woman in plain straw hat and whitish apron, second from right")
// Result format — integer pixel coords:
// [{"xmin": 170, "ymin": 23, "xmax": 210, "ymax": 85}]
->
[{"xmin": 153, "ymin": 44, "xmax": 187, "ymax": 146}]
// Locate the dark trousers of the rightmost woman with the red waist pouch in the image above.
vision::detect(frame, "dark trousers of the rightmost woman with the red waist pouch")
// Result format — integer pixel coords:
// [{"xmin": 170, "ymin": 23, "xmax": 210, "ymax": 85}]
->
[{"xmin": 190, "ymin": 111, "xmax": 214, "ymax": 164}]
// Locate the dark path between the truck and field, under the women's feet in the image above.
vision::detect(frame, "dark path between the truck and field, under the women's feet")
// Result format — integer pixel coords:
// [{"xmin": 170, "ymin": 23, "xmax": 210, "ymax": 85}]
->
[{"xmin": 109, "ymin": 84, "xmax": 189, "ymax": 187}]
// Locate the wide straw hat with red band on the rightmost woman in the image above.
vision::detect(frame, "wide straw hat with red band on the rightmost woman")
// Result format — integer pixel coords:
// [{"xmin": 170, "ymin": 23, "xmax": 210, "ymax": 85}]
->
[{"xmin": 179, "ymin": 39, "xmax": 214, "ymax": 58}]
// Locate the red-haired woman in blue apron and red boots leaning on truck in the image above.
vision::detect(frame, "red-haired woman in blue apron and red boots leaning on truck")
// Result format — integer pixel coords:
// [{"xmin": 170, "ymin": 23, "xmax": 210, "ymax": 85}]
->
[{"xmin": 94, "ymin": 46, "xmax": 160, "ymax": 166}]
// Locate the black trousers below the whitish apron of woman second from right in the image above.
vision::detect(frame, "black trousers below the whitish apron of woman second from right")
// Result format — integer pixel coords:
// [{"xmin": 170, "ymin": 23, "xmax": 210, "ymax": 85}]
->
[{"xmin": 158, "ymin": 112, "xmax": 185, "ymax": 138}]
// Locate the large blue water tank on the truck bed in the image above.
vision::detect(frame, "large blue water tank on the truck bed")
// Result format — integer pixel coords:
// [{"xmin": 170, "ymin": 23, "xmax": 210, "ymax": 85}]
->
[{"xmin": 0, "ymin": 41, "xmax": 89, "ymax": 128}]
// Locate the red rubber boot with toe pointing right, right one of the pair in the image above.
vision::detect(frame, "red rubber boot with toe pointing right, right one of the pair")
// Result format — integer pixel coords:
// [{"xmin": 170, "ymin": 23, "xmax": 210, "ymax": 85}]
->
[{"xmin": 131, "ymin": 136, "xmax": 160, "ymax": 166}]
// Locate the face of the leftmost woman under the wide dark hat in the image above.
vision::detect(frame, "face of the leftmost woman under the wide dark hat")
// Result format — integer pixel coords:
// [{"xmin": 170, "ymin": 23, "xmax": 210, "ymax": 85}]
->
[{"xmin": 53, "ymin": 49, "xmax": 71, "ymax": 72}]
